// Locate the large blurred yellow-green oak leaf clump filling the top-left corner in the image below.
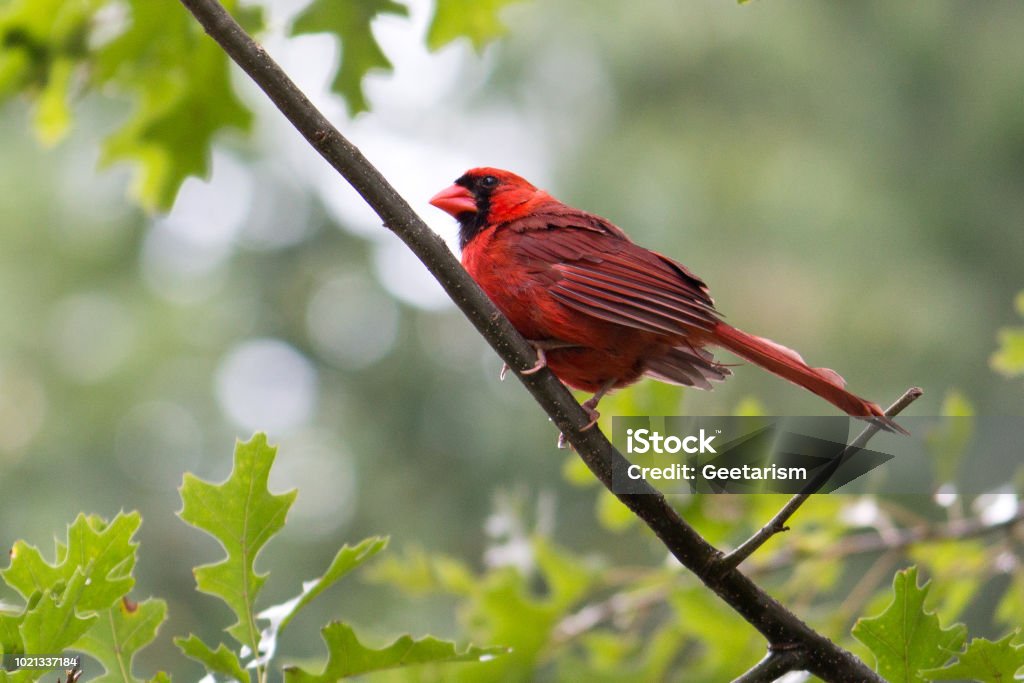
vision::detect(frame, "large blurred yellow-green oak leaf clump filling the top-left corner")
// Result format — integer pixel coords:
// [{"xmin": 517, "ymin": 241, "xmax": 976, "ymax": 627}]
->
[{"xmin": 0, "ymin": 0, "xmax": 254, "ymax": 209}]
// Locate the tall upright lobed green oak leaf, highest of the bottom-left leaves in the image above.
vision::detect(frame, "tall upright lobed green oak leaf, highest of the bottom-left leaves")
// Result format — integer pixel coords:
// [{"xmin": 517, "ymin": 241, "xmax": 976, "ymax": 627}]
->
[{"xmin": 178, "ymin": 434, "xmax": 296, "ymax": 652}]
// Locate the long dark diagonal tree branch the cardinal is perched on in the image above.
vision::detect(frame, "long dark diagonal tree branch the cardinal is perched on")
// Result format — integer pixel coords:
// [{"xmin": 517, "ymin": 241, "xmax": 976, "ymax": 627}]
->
[{"xmin": 181, "ymin": 0, "xmax": 905, "ymax": 683}]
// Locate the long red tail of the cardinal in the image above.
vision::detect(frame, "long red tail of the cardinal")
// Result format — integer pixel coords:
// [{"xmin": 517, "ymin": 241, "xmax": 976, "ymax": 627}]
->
[{"xmin": 712, "ymin": 323, "xmax": 907, "ymax": 434}]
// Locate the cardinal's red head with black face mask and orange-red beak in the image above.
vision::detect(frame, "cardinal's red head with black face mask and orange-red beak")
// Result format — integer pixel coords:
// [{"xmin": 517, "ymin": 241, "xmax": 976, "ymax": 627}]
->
[{"xmin": 430, "ymin": 167, "xmax": 551, "ymax": 248}]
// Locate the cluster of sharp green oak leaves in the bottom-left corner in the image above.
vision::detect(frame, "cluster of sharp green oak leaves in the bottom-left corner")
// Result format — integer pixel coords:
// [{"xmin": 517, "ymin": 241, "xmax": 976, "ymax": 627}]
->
[{"xmin": 0, "ymin": 434, "xmax": 506, "ymax": 683}]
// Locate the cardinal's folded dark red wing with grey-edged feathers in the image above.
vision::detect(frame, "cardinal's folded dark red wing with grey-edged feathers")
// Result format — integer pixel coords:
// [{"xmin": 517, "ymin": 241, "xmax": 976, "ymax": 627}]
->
[{"xmin": 513, "ymin": 212, "xmax": 719, "ymax": 337}]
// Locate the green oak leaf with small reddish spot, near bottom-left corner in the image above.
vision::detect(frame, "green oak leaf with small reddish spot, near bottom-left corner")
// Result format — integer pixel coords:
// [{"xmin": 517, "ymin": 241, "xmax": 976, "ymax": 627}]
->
[{"xmin": 74, "ymin": 598, "xmax": 167, "ymax": 683}]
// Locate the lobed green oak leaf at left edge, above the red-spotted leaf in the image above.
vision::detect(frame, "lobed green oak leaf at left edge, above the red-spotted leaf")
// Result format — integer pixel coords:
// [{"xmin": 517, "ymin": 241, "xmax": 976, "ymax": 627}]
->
[{"xmin": 0, "ymin": 512, "xmax": 142, "ymax": 614}]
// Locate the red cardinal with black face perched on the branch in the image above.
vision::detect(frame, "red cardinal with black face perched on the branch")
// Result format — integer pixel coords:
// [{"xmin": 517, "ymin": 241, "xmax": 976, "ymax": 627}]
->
[{"xmin": 430, "ymin": 168, "xmax": 904, "ymax": 432}]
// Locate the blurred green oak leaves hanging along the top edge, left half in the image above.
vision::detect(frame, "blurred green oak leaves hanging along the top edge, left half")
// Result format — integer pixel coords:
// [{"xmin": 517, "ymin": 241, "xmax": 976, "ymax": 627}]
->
[{"xmin": 0, "ymin": 0, "xmax": 510, "ymax": 210}]
